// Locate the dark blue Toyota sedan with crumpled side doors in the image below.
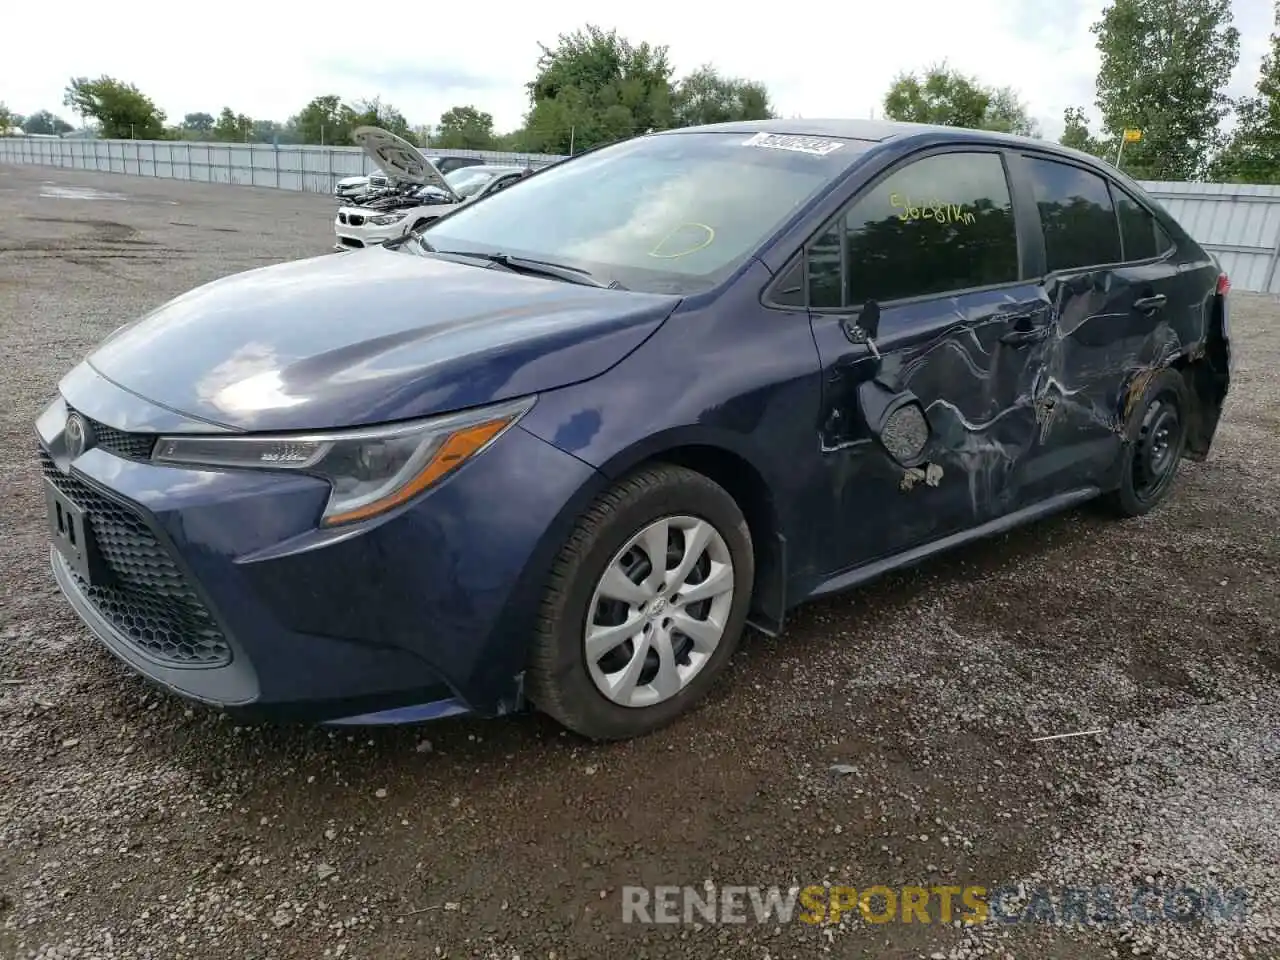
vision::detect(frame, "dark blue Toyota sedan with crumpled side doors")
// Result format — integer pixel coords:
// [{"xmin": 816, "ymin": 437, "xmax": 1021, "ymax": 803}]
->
[{"xmin": 36, "ymin": 120, "xmax": 1230, "ymax": 739}]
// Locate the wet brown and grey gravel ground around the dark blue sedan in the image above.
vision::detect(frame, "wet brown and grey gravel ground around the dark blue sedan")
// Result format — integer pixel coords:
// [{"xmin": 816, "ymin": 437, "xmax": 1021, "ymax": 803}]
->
[{"xmin": 0, "ymin": 166, "xmax": 1280, "ymax": 960}]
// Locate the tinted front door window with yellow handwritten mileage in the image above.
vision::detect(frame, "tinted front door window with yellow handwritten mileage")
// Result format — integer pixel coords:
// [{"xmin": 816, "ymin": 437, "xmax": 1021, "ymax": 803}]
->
[{"xmin": 806, "ymin": 152, "xmax": 1019, "ymax": 307}]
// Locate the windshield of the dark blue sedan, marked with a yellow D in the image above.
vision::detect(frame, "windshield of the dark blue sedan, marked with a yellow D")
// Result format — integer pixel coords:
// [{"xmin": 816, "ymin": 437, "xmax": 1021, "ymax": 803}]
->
[{"xmin": 414, "ymin": 133, "xmax": 872, "ymax": 293}]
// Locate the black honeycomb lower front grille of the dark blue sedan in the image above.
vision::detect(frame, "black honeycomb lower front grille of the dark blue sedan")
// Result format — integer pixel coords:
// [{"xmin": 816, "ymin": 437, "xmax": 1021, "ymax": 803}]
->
[{"xmin": 40, "ymin": 449, "xmax": 232, "ymax": 667}]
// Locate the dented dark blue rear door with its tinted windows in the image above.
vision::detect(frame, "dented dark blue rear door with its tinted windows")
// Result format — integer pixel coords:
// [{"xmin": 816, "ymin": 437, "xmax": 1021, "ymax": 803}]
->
[{"xmin": 1011, "ymin": 152, "xmax": 1188, "ymax": 502}]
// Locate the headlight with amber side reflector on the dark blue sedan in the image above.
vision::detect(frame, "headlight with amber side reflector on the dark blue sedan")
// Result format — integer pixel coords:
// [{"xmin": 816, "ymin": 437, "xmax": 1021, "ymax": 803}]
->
[{"xmin": 151, "ymin": 397, "xmax": 535, "ymax": 526}]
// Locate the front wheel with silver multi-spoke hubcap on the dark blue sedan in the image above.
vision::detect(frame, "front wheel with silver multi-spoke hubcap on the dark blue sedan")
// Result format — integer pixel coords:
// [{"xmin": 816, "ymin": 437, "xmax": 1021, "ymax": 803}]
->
[{"xmin": 526, "ymin": 465, "xmax": 755, "ymax": 740}]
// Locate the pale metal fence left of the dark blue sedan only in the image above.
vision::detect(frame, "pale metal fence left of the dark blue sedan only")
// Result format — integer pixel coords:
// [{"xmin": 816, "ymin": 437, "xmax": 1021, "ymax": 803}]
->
[{"xmin": 0, "ymin": 137, "xmax": 561, "ymax": 193}]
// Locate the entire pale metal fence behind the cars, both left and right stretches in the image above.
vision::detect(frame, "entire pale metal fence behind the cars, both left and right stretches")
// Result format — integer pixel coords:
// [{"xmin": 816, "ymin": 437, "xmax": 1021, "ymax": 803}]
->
[{"xmin": 0, "ymin": 137, "xmax": 1280, "ymax": 293}]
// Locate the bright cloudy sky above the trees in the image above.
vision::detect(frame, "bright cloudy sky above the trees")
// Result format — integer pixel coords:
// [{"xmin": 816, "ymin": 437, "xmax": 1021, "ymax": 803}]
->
[{"xmin": 0, "ymin": 0, "xmax": 1272, "ymax": 136}]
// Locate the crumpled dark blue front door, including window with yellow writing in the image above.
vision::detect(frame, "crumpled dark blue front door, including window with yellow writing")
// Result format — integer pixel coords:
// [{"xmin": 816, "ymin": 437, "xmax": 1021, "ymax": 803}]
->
[{"xmin": 805, "ymin": 147, "xmax": 1051, "ymax": 572}]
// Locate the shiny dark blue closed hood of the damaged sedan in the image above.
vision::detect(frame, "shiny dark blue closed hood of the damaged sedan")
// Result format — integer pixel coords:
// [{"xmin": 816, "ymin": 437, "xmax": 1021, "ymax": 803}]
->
[{"xmin": 84, "ymin": 248, "xmax": 680, "ymax": 430}]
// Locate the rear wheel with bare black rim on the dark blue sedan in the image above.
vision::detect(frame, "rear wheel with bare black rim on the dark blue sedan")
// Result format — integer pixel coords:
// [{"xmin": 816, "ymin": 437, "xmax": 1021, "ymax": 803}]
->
[{"xmin": 1102, "ymin": 369, "xmax": 1190, "ymax": 517}]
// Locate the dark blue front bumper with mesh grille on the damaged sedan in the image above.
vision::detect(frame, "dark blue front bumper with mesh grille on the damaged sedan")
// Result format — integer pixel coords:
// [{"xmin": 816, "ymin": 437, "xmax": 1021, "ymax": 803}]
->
[{"xmin": 37, "ymin": 367, "xmax": 595, "ymax": 723}]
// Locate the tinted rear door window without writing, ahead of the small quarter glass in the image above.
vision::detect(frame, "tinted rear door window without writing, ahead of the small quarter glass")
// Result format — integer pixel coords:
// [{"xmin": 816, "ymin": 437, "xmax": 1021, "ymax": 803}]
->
[{"xmin": 1027, "ymin": 157, "xmax": 1124, "ymax": 273}]
